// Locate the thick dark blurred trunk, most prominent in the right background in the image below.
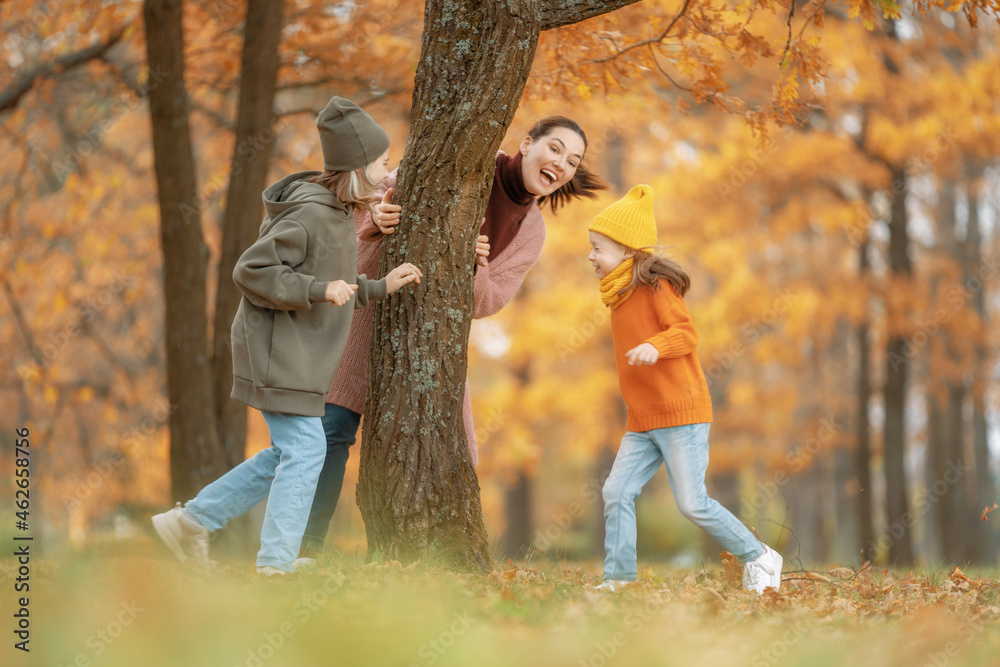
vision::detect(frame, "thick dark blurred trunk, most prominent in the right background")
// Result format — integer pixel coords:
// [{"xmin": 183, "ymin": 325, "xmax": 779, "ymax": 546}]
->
[{"xmin": 883, "ymin": 168, "xmax": 913, "ymax": 566}]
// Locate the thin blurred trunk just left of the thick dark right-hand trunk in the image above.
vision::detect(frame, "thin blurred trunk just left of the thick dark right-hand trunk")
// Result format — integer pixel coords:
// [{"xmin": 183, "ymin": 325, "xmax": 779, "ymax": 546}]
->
[{"xmin": 854, "ymin": 230, "xmax": 875, "ymax": 561}]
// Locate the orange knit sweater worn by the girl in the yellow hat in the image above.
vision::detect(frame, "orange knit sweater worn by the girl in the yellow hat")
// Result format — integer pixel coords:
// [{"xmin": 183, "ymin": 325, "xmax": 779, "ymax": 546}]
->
[{"xmin": 611, "ymin": 279, "xmax": 712, "ymax": 432}]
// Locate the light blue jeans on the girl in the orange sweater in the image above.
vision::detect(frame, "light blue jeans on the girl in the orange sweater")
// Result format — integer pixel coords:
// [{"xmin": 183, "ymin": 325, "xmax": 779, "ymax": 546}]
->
[{"xmin": 603, "ymin": 424, "xmax": 764, "ymax": 581}]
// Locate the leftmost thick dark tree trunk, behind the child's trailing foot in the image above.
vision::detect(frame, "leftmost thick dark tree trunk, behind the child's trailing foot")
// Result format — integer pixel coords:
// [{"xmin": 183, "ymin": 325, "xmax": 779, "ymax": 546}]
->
[{"xmin": 143, "ymin": 0, "xmax": 225, "ymax": 500}]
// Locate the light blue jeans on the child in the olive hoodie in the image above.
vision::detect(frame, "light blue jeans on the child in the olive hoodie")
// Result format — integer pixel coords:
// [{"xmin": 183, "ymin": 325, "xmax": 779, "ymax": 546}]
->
[{"xmin": 184, "ymin": 412, "xmax": 326, "ymax": 572}]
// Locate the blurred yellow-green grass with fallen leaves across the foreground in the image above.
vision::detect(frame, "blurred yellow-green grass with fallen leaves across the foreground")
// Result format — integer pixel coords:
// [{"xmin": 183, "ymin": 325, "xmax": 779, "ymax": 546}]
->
[{"xmin": 0, "ymin": 540, "xmax": 1000, "ymax": 667}]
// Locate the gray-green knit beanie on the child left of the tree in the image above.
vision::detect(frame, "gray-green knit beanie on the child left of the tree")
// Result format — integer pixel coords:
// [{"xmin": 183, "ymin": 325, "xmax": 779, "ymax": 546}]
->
[{"xmin": 316, "ymin": 97, "xmax": 389, "ymax": 171}]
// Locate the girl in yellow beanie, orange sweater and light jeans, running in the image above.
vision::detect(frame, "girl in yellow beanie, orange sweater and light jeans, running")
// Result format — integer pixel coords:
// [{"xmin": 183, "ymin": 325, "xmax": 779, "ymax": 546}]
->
[{"xmin": 588, "ymin": 185, "xmax": 782, "ymax": 593}]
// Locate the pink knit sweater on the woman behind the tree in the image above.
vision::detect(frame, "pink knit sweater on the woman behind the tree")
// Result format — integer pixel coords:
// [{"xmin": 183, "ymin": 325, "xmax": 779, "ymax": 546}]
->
[{"xmin": 326, "ymin": 160, "xmax": 545, "ymax": 464}]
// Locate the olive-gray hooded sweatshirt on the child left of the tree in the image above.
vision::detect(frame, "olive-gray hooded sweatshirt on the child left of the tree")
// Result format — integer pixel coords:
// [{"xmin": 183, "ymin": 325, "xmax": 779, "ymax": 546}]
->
[{"xmin": 232, "ymin": 171, "xmax": 386, "ymax": 417}]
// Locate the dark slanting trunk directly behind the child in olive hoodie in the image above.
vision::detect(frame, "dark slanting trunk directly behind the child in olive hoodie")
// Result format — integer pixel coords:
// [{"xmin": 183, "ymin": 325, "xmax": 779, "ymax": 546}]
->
[{"xmin": 212, "ymin": 0, "xmax": 284, "ymax": 467}]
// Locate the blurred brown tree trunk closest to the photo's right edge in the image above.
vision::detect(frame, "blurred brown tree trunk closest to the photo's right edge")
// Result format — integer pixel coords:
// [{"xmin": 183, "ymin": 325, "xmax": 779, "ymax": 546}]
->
[{"xmin": 962, "ymin": 165, "xmax": 998, "ymax": 565}]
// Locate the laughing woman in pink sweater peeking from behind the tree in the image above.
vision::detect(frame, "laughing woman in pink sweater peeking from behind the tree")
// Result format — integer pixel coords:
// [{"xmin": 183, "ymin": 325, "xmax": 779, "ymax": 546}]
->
[{"xmin": 296, "ymin": 116, "xmax": 606, "ymax": 566}]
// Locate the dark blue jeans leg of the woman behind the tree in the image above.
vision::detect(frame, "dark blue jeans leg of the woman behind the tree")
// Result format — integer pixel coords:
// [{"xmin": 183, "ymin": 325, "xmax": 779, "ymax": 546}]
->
[{"xmin": 301, "ymin": 403, "xmax": 361, "ymax": 555}]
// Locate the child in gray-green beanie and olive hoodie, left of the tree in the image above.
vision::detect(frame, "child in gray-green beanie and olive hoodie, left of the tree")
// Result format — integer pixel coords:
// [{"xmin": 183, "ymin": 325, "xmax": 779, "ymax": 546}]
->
[{"xmin": 152, "ymin": 97, "xmax": 423, "ymax": 575}]
